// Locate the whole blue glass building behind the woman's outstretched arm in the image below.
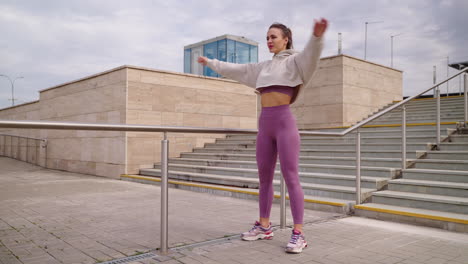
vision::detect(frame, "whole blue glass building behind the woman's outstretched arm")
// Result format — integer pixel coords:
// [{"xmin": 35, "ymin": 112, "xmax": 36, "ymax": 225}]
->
[{"xmin": 184, "ymin": 35, "xmax": 258, "ymax": 77}]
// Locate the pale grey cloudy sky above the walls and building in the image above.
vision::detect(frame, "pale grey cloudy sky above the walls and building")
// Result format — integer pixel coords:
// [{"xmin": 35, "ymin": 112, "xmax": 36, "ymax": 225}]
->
[{"xmin": 0, "ymin": 0, "xmax": 468, "ymax": 108}]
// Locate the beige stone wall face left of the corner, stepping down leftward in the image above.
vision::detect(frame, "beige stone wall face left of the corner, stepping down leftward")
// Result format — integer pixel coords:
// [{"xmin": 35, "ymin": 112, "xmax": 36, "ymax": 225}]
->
[{"xmin": 0, "ymin": 68, "xmax": 127, "ymax": 178}]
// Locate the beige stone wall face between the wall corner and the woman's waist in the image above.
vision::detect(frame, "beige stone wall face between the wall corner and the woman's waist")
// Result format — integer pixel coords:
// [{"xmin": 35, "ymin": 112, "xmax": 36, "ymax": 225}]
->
[{"xmin": 126, "ymin": 67, "xmax": 257, "ymax": 173}]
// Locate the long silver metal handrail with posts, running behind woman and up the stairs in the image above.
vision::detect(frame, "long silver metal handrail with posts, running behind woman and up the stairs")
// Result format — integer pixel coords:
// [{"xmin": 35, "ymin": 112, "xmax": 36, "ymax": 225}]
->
[{"xmin": 0, "ymin": 68, "xmax": 468, "ymax": 254}]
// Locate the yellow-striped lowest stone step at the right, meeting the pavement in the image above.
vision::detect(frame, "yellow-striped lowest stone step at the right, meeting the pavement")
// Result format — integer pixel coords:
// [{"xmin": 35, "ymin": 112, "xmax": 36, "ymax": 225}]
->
[{"xmin": 354, "ymin": 203, "xmax": 468, "ymax": 233}]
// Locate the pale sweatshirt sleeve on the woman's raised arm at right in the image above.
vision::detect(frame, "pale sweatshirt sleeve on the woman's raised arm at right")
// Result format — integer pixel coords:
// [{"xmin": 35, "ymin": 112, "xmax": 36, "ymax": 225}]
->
[{"xmin": 294, "ymin": 34, "xmax": 323, "ymax": 85}]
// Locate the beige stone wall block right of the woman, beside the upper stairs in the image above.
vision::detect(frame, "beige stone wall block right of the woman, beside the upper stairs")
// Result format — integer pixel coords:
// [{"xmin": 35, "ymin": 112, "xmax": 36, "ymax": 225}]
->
[{"xmin": 291, "ymin": 55, "xmax": 403, "ymax": 129}]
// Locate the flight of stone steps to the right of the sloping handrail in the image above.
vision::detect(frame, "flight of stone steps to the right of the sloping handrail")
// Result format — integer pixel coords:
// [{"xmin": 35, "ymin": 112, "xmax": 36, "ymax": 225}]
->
[{"xmin": 355, "ymin": 127, "xmax": 468, "ymax": 233}]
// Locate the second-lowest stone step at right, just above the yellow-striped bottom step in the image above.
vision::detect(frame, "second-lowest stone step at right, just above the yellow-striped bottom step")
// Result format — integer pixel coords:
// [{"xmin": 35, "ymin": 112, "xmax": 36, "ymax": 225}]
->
[{"xmin": 371, "ymin": 191, "xmax": 468, "ymax": 214}]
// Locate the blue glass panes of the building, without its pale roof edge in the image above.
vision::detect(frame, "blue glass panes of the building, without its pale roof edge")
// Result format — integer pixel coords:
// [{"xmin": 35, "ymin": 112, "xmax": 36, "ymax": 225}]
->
[{"xmin": 184, "ymin": 38, "xmax": 258, "ymax": 77}]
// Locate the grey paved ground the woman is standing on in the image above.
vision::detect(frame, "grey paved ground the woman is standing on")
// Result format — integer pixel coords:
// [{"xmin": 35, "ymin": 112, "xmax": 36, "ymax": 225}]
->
[{"xmin": 0, "ymin": 157, "xmax": 468, "ymax": 264}]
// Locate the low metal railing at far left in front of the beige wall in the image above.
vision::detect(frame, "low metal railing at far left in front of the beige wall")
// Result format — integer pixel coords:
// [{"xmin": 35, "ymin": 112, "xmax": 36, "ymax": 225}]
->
[{"xmin": 0, "ymin": 134, "xmax": 47, "ymax": 167}]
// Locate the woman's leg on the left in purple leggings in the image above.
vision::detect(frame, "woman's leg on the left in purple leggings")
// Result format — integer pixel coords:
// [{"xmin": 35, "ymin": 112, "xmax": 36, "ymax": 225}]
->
[{"xmin": 256, "ymin": 120, "xmax": 277, "ymax": 227}]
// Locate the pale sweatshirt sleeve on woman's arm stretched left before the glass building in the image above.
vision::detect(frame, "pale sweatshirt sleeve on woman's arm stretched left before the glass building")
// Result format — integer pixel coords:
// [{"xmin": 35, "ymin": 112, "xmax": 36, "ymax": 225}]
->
[{"xmin": 207, "ymin": 59, "xmax": 262, "ymax": 89}]
